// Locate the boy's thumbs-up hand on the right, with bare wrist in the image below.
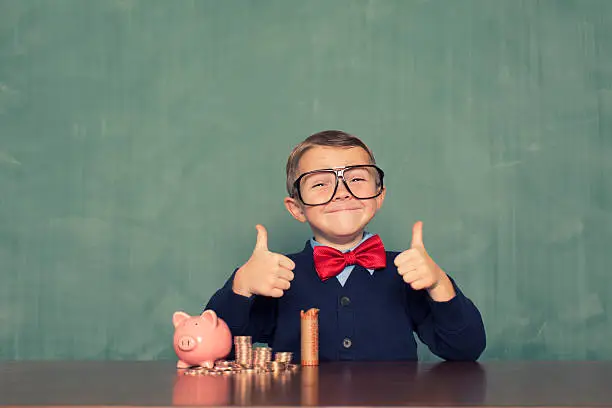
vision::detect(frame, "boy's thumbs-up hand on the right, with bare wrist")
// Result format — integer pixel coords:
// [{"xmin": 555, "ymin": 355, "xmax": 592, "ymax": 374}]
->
[{"xmin": 394, "ymin": 221, "xmax": 455, "ymax": 302}]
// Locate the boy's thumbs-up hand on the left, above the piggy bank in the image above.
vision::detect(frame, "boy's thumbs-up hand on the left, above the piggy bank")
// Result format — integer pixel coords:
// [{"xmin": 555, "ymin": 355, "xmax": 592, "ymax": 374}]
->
[{"xmin": 232, "ymin": 224, "xmax": 295, "ymax": 298}]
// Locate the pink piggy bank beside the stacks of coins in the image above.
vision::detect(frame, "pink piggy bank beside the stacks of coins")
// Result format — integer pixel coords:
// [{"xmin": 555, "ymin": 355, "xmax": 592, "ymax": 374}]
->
[{"xmin": 172, "ymin": 310, "xmax": 232, "ymax": 368}]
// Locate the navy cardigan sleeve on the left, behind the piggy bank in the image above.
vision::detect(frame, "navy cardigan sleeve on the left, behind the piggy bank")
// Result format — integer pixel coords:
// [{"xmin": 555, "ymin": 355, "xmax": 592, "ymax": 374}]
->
[{"xmin": 206, "ymin": 271, "xmax": 278, "ymax": 343}]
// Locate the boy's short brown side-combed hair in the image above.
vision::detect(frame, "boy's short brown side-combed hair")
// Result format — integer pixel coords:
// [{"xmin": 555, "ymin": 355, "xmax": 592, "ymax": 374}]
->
[{"xmin": 286, "ymin": 130, "xmax": 376, "ymax": 197}]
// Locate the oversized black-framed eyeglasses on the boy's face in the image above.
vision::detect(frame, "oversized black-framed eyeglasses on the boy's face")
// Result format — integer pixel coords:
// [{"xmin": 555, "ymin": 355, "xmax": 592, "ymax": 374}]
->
[{"xmin": 293, "ymin": 164, "xmax": 385, "ymax": 206}]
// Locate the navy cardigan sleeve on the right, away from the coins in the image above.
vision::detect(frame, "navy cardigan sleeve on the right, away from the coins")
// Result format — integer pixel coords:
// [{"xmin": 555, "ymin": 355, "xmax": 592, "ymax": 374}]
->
[{"xmin": 406, "ymin": 277, "xmax": 486, "ymax": 361}]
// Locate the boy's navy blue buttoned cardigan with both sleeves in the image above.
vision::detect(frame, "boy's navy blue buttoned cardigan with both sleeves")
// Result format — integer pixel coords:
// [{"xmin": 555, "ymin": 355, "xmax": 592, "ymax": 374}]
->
[{"xmin": 206, "ymin": 241, "xmax": 486, "ymax": 361}]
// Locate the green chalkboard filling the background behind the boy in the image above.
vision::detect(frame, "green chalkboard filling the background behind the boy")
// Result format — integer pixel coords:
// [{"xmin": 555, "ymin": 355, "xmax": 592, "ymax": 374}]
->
[{"xmin": 0, "ymin": 0, "xmax": 612, "ymax": 359}]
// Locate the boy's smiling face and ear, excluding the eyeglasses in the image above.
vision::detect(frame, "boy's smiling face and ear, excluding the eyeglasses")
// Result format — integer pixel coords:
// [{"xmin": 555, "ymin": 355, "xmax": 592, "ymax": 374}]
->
[{"xmin": 285, "ymin": 146, "xmax": 385, "ymax": 249}]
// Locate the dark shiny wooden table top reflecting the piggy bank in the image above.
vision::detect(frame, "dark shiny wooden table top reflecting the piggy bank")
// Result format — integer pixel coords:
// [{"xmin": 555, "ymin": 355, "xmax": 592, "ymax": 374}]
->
[{"xmin": 0, "ymin": 361, "xmax": 612, "ymax": 406}]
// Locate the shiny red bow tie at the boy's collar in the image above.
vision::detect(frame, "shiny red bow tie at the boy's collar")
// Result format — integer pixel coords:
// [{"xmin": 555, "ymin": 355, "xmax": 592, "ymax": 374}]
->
[{"xmin": 313, "ymin": 235, "xmax": 387, "ymax": 281}]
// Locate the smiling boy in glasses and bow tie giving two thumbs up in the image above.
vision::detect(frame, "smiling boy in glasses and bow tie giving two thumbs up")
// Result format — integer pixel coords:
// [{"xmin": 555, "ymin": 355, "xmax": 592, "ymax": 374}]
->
[{"xmin": 206, "ymin": 130, "xmax": 486, "ymax": 361}]
